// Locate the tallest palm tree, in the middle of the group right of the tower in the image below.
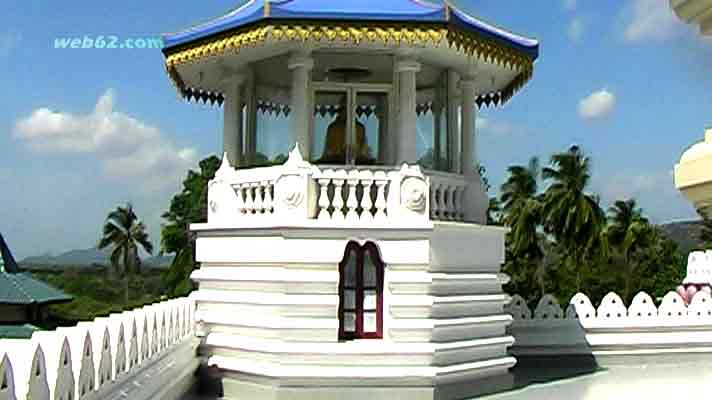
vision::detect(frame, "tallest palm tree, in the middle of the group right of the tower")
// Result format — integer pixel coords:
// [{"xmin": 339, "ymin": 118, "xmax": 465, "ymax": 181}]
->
[{"xmin": 542, "ymin": 146, "xmax": 608, "ymax": 290}]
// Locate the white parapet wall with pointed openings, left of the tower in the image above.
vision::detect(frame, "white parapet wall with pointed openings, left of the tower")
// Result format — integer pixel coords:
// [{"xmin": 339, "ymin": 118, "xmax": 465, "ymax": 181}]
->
[{"xmin": 0, "ymin": 297, "xmax": 199, "ymax": 400}]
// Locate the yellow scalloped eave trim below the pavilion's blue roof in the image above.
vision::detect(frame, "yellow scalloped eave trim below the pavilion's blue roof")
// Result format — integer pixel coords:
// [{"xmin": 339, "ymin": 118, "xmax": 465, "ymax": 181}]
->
[{"xmin": 166, "ymin": 22, "xmax": 534, "ymax": 105}]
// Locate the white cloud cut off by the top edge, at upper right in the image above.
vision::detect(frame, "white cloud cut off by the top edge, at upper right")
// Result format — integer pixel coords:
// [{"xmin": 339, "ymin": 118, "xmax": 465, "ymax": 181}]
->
[{"xmin": 624, "ymin": 0, "xmax": 682, "ymax": 42}]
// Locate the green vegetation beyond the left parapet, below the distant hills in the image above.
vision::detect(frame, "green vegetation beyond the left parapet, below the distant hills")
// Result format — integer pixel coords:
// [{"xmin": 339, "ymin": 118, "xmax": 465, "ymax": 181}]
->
[{"xmin": 32, "ymin": 267, "xmax": 166, "ymax": 329}]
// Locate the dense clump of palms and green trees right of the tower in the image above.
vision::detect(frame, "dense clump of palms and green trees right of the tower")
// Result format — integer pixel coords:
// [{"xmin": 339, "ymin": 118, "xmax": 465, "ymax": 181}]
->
[{"xmin": 499, "ymin": 146, "xmax": 688, "ymax": 307}]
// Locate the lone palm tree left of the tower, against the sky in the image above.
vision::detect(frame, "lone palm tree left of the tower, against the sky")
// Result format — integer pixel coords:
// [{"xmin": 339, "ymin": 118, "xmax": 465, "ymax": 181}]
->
[{"xmin": 98, "ymin": 203, "xmax": 153, "ymax": 303}]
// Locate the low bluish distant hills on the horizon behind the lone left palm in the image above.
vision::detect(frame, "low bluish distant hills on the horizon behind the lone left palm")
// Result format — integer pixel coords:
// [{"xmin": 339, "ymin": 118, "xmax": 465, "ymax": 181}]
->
[{"xmin": 19, "ymin": 248, "xmax": 173, "ymax": 268}]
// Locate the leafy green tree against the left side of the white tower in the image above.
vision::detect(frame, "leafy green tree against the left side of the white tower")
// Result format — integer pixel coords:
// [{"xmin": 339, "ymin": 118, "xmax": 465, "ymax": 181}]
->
[{"xmin": 161, "ymin": 156, "xmax": 221, "ymax": 296}]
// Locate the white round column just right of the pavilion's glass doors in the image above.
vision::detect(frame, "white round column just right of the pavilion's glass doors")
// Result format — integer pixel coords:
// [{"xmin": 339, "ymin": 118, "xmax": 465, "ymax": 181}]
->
[{"xmin": 396, "ymin": 59, "xmax": 420, "ymax": 164}]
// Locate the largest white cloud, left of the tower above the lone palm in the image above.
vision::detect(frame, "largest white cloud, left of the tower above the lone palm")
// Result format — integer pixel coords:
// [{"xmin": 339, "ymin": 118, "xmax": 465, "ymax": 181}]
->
[{"xmin": 14, "ymin": 89, "xmax": 197, "ymax": 191}]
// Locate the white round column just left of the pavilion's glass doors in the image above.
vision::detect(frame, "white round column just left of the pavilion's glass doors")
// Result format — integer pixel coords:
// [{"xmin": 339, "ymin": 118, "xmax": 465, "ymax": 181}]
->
[{"xmin": 289, "ymin": 54, "xmax": 314, "ymax": 160}]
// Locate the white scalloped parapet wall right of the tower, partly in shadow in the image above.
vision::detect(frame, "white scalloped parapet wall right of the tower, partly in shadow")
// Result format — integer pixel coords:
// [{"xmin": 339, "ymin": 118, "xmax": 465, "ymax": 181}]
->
[{"xmin": 506, "ymin": 292, "xmax": 712, "ymax": 363}]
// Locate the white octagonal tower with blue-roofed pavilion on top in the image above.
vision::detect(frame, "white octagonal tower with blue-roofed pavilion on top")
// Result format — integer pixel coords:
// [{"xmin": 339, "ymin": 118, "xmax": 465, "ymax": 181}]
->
[{"xmin": 164, "ymin": 0, "xmax": 538, "ymax": 399}]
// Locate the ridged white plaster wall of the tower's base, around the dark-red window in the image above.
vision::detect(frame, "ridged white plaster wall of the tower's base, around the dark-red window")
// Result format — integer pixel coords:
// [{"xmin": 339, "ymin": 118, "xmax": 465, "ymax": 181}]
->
[{"xmin": 192, "ymin": 223, "xmax": 515, "ymax": 396}]
